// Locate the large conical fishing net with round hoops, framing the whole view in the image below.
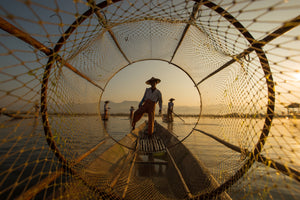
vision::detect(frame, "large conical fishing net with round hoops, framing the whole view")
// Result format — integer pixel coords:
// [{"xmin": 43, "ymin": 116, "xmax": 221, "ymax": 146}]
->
[{"xmin": 0, "ymin": 0, "xmax": 300, "ymax": 199}]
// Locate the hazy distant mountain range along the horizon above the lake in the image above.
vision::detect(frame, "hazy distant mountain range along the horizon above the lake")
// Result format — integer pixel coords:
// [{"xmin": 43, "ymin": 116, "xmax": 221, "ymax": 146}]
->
[{"xmin": 0, "ymin": 101, "xmax": 288, "ymax": 115}]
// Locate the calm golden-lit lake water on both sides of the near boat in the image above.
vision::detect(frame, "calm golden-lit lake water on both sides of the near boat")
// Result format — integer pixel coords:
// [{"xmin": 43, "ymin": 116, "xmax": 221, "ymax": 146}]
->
[{"xmin": 0, "ymin": 116, "xmax": 300, "ymax": 199}]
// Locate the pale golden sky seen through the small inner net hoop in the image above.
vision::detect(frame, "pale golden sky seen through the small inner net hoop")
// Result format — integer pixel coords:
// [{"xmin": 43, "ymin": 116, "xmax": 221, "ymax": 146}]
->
[{"xmin": 102, "ymin": 61, "xmax": 199, "ymax": 106}]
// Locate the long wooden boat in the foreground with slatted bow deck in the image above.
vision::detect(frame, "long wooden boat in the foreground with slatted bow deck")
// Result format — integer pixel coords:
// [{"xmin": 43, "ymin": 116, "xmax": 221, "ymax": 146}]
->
[{"xmin": 64, "ymin": 122, "xmax": 231, "ymax": 199}]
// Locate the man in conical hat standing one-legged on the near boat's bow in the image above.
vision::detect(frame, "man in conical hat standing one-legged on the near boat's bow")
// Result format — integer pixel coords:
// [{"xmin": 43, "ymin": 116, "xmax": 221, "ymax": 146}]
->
[{"xmin": 131, "ymin": 77, "xmax": 162, "ymax": 136}]
